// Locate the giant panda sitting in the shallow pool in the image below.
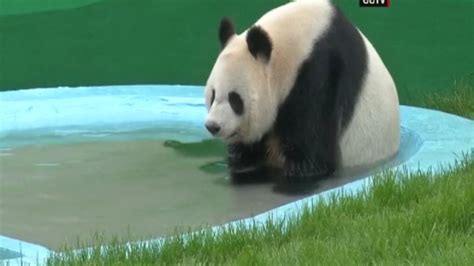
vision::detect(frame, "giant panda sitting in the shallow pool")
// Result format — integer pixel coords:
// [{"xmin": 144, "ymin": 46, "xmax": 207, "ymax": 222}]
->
[{"xmin": 204, "ymin": 0, "xmax": 400, "ymax": 193}]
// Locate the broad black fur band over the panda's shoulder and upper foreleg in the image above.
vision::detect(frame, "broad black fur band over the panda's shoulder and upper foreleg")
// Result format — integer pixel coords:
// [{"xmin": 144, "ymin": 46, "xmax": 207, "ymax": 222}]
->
[{"xmin": 275, "ymin": 4, "xmax": 368, "ymax": 165}]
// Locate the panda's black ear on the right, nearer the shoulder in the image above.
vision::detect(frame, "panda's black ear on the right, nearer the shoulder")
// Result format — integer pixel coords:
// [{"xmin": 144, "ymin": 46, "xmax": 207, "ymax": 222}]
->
[{"xmin": 247, "ymin": 26, "xmax": 273, "ymax": 62}]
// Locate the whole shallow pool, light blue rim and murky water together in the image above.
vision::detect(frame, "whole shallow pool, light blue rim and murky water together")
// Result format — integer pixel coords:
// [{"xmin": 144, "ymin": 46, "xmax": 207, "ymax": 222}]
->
[{"xmin": 0, "ymin": 86, "xmax": 474, "ymax": 264}]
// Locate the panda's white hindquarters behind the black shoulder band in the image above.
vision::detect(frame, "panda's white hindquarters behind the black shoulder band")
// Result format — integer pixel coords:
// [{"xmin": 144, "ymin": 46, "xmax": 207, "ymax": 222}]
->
[{"xmin": 340, "ymin": 32, "xmax": 400, "ymax": 167}]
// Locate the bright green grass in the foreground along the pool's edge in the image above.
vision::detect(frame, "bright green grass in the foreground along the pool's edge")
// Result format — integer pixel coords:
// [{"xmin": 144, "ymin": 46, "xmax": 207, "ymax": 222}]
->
[{"xmin": 48, "ymin": 154, "xmax": 474, "ymax": 265}]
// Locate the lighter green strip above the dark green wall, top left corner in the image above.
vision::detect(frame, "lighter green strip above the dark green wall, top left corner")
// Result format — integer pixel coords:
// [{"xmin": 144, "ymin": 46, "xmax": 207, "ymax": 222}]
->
[{"xmin": 0, "ymin": 0, "xmax": 101, "ymax": 16}]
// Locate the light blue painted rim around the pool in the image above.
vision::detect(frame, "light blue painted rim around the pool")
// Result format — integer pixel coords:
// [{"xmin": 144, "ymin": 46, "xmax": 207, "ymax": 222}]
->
[{"xmin": 0, "ymin": 85, "xmax": 474, "ymax": 265}]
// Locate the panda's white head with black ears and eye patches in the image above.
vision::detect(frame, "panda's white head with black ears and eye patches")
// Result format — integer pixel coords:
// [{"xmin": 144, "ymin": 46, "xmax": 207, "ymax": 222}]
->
[{"xmin": 205, "ymin": 18, "xmax": 276, "ymax": 144}]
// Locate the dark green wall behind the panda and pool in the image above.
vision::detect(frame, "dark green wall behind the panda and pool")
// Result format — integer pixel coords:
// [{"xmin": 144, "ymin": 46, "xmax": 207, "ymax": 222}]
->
[{"xmin": 0, "ymin": 0, "xmax": 474, "ymax": 102}]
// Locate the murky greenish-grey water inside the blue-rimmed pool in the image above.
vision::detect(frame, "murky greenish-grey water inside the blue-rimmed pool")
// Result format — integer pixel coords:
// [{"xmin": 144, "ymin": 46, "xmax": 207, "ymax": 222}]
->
[{"xmin": 0, "ymin": 125, "xmax": 420, "ymax": 249}]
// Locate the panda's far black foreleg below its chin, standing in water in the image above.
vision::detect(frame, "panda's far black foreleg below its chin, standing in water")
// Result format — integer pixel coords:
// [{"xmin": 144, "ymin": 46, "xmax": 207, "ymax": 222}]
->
[{"xmin": 228, "ymin": 142, "xmax": 270, "ymax": 184}]
